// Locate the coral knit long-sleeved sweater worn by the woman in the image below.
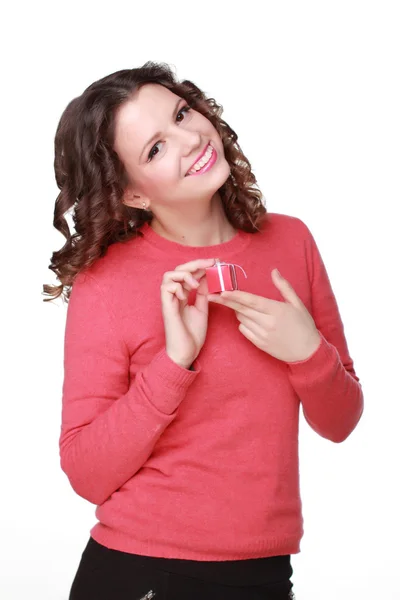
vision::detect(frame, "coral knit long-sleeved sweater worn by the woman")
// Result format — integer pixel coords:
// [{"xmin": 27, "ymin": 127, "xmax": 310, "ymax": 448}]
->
[{"xmin": 60, "ymin": 213, "xmax": 363, "ymax": 561}]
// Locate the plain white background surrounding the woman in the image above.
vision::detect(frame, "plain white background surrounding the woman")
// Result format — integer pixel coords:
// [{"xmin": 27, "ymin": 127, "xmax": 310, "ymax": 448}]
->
[{"xmin": 0, "ymin": 0, "xmax": 400, "ymax": 600}]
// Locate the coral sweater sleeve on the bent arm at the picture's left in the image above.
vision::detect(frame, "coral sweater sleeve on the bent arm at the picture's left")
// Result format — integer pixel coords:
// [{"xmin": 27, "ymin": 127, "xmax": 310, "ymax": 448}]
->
[{"xmin": 59, "ymin": 273, "xmax": 201, "ymax": 504}]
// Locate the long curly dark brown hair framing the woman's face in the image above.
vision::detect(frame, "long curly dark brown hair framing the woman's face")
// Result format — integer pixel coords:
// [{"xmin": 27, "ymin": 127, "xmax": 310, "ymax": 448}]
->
[{"xmin": 43, "ymin": 61, "xmax": 267, "ymax": 302}]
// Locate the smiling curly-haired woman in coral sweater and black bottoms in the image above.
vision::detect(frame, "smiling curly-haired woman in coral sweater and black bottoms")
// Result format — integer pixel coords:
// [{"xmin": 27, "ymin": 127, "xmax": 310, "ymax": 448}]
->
[{"xmin": 44, "ymin": 62, "xmax": 363, "ymax": 600}]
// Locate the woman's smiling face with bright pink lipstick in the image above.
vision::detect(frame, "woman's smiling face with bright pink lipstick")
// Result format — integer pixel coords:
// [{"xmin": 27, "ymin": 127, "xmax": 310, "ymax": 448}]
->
[{"xmin": 114, "ymin": 84, "xmax": 230, "ymax": 210}]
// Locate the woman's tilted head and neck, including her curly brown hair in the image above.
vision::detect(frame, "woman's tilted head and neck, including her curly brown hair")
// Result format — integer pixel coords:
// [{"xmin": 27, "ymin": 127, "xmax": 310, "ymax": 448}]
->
[{"xmin": 44, "ymin": 62, "xmax": 266, "ymax": 300}]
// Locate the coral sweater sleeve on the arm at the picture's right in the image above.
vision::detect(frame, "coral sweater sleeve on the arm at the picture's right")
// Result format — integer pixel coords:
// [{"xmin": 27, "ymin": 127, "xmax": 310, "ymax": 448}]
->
[{"xmin": 287, "ymin": 223, "xmax": 364, "ymax": 442}]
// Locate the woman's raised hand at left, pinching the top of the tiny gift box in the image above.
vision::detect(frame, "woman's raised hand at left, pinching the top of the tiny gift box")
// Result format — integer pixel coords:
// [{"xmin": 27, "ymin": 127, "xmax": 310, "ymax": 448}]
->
[{"xmin": 161, "ymin": 258, "xmax": 216, "ymax": 369}]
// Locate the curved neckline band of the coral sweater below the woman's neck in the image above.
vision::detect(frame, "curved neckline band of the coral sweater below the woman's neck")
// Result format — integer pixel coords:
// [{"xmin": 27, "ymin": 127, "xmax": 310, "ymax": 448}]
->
[{"xmin": 141, "ymin": 222, "xmax": 251, "ymax": 259}]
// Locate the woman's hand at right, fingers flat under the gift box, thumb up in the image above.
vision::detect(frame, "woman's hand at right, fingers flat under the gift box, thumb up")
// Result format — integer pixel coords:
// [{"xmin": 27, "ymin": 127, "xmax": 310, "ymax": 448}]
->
[{"xmin": 208, "ymin": 269, "xmax": 321, "ymax": 363}]
